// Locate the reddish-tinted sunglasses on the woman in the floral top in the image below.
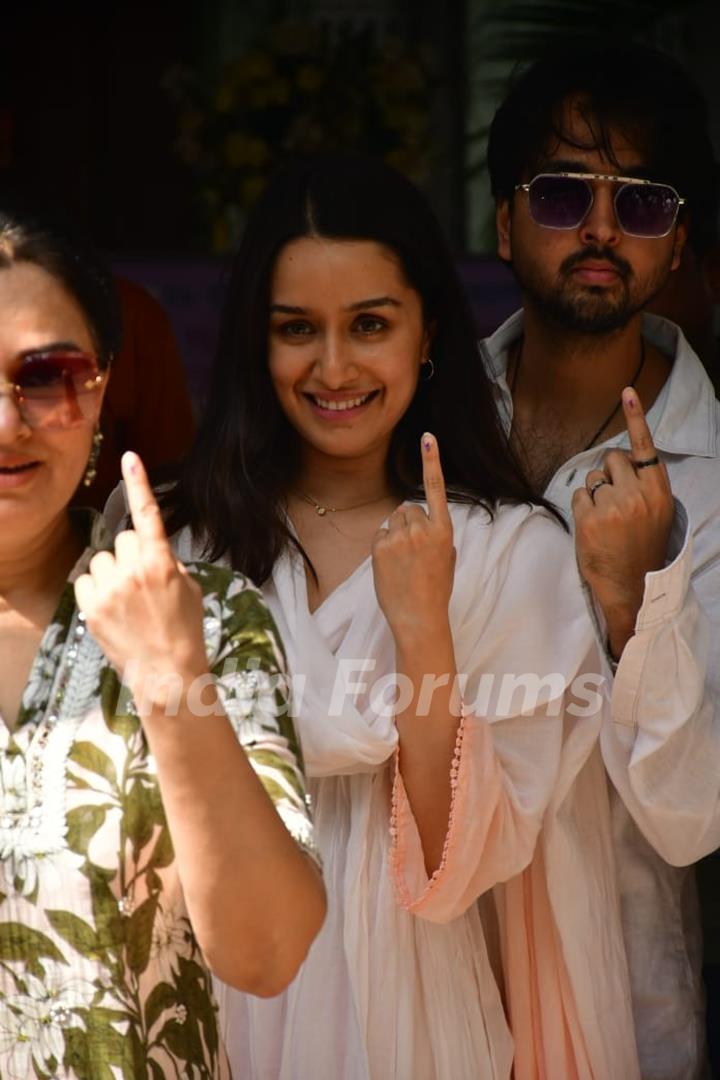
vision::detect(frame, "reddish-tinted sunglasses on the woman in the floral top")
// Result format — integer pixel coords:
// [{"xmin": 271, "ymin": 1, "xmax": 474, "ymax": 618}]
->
[{"xmin": 0, "ymin": 349, "xmax": 106, "ymax": 431}]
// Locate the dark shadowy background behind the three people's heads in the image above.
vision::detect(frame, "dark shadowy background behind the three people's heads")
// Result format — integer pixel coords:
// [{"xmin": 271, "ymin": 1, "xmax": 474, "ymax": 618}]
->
[{"xmin": 0, "ymin": 0, "xmax": 720, "ymax": 401}]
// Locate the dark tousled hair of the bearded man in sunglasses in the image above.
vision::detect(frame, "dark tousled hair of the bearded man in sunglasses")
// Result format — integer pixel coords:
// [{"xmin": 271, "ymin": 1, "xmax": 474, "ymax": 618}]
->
[{"xmin": 488, "ymin": 41, "xmax": 720, "ymax": 256}]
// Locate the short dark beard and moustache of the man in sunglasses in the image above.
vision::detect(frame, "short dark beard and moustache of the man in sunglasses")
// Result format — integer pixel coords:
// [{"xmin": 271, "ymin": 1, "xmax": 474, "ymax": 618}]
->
[{"xmin": 513, "ymin": 247, "xmax": 673, "ymax": 335}]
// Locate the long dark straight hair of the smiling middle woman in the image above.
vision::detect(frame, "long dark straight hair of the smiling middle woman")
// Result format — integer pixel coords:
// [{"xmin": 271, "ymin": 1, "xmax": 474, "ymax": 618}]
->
[{"xmin": 163, "ymin": 154, "xmax": 557, "ymax": 583}]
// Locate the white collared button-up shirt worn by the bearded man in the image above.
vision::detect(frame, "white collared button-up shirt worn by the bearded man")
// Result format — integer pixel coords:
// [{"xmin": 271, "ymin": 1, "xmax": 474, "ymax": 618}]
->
[{"xmin": 481, "ymin": 312, "xmax": 720, "ymax": 1080}]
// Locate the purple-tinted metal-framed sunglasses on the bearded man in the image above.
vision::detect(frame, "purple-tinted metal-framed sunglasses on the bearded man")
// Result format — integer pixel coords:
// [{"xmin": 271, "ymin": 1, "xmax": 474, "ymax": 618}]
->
[{"xmin": 515, "ymin": 173, "xmax": 685, "ymax": 240}]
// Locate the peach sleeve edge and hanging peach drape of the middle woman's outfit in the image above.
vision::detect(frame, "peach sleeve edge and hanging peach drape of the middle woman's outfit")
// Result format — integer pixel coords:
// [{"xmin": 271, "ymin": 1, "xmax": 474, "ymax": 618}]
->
[{"xmin": 391, "ymin": 650, "xmax": 640, "ymax": 1080}]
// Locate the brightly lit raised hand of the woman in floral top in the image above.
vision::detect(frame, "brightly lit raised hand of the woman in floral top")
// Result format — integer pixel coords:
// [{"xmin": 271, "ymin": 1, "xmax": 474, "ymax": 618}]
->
[{"xmin": 74, "ymin": 453, "xmax": 207, "ymax": 715}]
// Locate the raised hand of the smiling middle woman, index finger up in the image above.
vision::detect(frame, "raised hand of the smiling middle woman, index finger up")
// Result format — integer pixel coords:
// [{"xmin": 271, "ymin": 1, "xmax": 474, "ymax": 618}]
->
[{"xmin": 372, "ymin": 434, "xmax": 456, "ymax": 642}]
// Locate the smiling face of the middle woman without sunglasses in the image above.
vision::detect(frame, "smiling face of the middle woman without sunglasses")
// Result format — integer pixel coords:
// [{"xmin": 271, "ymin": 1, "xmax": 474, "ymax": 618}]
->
[{"xmin": 269, "ymin": 237, "xmax": 431, "ymax": 466}]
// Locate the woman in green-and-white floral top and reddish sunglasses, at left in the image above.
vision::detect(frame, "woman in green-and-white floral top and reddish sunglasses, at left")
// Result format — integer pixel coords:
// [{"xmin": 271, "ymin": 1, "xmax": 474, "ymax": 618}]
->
[{"xmin": 0, "ymin": 202, "xmax": 325, "ymax": 1080}]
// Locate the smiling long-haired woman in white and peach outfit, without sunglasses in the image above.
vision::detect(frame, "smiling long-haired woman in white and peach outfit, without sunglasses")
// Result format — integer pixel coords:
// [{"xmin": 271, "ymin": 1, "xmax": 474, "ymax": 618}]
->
[{"xmin": 120, "ymin": 154, "xmax": 639, "ymax": 1080}]
